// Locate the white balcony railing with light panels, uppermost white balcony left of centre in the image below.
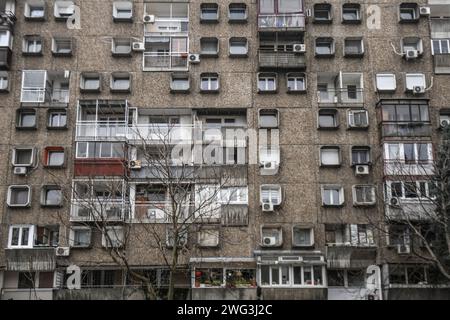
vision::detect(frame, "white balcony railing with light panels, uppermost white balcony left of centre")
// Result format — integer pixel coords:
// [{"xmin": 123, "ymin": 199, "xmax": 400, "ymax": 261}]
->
[{"xmin": 144, "ymin": 52, "xmax": 188, "ymax": 71}]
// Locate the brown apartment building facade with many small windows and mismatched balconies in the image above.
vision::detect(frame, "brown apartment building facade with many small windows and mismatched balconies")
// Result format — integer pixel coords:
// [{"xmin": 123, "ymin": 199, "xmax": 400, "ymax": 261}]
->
[{"xmin": 0, "ymin": 0, "xmax": 450, "ymax": 300}]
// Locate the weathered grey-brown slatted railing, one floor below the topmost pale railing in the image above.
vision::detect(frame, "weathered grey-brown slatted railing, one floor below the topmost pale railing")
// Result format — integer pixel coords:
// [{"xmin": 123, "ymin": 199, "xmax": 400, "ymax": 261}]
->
[{"xmin": 258, "ymin": 50, "xmax": 306, "ymax": 69}]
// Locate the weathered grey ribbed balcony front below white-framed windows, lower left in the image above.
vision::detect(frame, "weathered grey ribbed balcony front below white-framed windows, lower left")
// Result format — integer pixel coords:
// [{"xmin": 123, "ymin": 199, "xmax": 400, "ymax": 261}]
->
[{"xmin": 5, "ymin": 248, "xmax": 56, "ymax": 271}]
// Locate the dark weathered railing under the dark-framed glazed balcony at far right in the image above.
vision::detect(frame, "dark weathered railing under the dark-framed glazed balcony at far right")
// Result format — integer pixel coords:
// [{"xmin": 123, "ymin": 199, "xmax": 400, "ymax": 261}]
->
[{"xmin": 381, "ymin": 122, "xmax": 432, "ymax": 137}]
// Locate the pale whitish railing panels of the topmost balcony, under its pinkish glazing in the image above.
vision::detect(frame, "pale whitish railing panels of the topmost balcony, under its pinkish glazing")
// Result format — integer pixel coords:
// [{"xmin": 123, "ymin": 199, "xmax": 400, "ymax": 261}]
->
[{"xmin": 258, "ymin": 13, "xmax": 305, "ymax": 30}]
